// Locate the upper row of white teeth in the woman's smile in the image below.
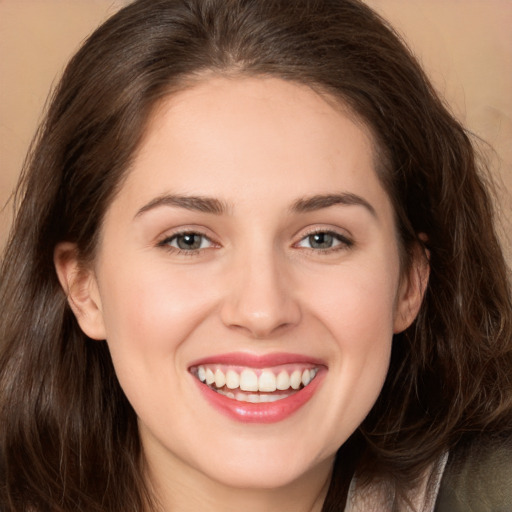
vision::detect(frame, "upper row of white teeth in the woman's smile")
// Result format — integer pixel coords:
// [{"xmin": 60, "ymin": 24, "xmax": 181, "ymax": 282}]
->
[{"xmin": 193, "ymin": 366, "xmax": 318, "ymax": 393}]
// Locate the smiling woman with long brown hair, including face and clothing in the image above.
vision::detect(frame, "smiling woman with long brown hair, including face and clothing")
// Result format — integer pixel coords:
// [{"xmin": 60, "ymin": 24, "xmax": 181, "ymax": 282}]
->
[{"xmin": 0, "ymin": 0, "xmax": 512, "ymax": 511}]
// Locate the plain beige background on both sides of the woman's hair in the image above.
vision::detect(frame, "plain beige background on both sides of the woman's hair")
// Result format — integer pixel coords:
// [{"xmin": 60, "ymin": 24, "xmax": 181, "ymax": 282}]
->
[{"xmin": 0, "ymin": 0, "xmax": 512, "ymax": 261}]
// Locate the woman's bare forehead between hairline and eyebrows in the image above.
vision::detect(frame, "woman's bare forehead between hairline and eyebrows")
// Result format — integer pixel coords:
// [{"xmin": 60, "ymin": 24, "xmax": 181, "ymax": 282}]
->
[{"xmin": 116, "ymin": 77, "xmax": 388, "ymax": 214}]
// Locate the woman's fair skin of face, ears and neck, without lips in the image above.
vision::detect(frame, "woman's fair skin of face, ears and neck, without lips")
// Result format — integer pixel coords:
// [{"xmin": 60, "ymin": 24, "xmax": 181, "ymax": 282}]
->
[{"xmin": 55, "ymin": 77, "xmax": 428, "ymax": 511}]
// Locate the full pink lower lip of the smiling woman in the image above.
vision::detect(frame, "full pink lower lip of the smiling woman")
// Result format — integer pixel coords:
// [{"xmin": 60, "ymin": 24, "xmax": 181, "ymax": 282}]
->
[{"xmin": 193, "ymin": 371, "xmax": 324, "ymax": 423}]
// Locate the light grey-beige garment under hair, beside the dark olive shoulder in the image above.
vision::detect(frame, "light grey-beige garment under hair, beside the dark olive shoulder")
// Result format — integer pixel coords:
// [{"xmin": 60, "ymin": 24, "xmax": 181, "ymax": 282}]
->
[{"xmin": 345, "ymin": 453, "xmax": 448, "ymax": 512}]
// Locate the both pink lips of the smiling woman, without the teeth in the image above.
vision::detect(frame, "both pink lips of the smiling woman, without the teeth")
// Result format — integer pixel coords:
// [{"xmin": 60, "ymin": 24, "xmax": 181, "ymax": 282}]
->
[{"xmin": 190, "ymin": 353, "xmax": 326, "ymax": 423}]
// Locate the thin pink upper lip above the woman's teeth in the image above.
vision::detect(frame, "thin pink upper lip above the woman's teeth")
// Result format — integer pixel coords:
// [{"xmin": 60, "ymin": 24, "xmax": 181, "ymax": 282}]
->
[{"xmin": 189, "ymin": 352, "xmax": 325, "ymax": 368}]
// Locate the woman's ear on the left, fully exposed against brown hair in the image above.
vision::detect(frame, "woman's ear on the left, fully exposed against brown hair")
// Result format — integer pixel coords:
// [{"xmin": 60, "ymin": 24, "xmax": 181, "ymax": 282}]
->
[{"xmin": 53, "ymin": 242, "xmax": 106, "ymax": 340}]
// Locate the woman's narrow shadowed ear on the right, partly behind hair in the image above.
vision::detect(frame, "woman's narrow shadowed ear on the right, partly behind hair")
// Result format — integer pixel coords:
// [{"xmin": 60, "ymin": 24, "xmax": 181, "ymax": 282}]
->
[{"xmin": 393, "ymin": 242, "xmax": 430, "ymax": 334}]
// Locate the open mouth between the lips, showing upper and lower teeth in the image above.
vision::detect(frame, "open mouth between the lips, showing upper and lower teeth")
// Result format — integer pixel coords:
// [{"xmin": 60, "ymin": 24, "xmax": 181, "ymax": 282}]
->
[{"xmin": 190, "ymin": 364, "xmax": 318, "ymax": 403}]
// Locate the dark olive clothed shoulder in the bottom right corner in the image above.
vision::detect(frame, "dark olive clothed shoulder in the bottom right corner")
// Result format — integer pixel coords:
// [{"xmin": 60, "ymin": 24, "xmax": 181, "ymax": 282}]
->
[{"xmin": 434, "ymin": 436, "xmax": 512, "ymax": 512}]
